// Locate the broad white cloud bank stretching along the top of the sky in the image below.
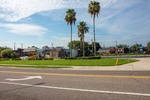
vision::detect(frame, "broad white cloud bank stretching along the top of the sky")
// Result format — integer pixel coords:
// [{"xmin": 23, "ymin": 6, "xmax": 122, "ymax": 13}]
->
[{"xmin": 0, "ymin": 0, "xmax": 138, "ymax": 22}]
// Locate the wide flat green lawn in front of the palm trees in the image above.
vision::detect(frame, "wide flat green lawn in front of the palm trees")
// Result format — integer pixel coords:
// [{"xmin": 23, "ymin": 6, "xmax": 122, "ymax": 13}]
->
[{"xmin": 0, "ymin": 58, "xmax": 138, "ymax": 66}]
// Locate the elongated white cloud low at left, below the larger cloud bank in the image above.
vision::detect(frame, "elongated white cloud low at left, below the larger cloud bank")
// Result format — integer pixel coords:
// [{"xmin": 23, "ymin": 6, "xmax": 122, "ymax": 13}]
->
[{"xmin": 0, "ymin": 23, "xmax": 47, "ymax": 37}]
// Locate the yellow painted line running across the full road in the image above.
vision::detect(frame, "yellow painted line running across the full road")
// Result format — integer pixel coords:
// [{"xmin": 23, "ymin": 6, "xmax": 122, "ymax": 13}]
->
[{"xmin": 0, "ymin": 71, "xmax": 150, "ymax": 78}]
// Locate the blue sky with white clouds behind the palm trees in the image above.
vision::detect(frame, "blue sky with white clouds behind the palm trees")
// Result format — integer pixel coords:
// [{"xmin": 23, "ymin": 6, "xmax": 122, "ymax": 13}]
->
[{"xmin": 0, "ymin": 0, "xmax": 150, "ymax": 48}]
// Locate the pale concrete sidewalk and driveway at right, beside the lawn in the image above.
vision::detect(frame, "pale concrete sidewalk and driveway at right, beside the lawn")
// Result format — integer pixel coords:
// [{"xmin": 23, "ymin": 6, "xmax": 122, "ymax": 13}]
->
[{"xmin": 63, "ymin": 58, "xmax": 150, "ymax": 71}]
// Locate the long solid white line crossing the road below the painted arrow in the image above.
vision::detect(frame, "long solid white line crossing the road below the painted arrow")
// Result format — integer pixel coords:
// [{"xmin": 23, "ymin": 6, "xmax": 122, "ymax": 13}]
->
[{"xmin": 0, "ymin": 81, "xmax": 150, "ymax": 96}]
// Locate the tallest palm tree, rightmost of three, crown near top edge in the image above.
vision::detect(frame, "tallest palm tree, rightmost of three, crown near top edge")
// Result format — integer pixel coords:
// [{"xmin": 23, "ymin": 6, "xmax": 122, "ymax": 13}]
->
[{"xmin": 88, "ymin": 1, "xmax": 101, "ymax": 56}]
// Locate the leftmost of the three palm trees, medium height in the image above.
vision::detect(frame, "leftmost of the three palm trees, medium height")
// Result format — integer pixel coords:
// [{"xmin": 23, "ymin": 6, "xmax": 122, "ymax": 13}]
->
[{"xmin": 65, "ymin": 9, "xmax": 76, "ymax": 57}]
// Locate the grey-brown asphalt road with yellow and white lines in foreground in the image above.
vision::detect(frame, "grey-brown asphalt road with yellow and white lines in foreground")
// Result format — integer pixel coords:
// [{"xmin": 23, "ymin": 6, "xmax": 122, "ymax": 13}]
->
[{"xmin": 0, "ymin": 67, "xmax": 150, "ymax": 100}]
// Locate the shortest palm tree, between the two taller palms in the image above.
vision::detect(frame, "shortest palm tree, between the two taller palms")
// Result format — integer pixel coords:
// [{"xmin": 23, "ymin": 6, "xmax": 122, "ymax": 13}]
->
[{"xmin": 77, "ymin": 21, "xmax": 89, "ymax": 57}]
